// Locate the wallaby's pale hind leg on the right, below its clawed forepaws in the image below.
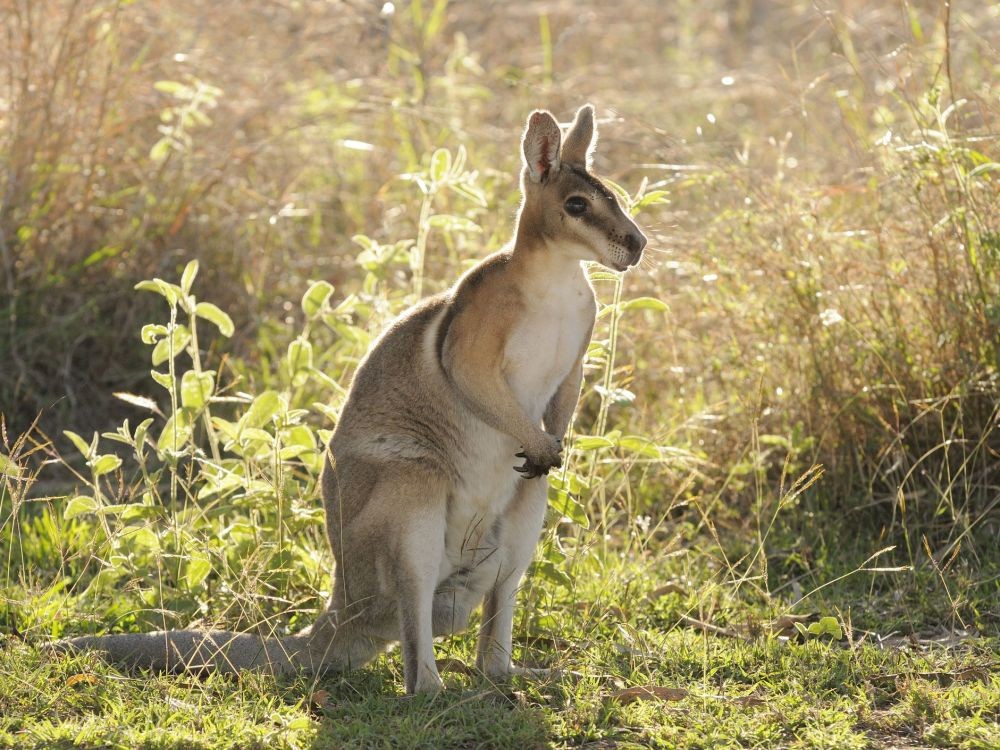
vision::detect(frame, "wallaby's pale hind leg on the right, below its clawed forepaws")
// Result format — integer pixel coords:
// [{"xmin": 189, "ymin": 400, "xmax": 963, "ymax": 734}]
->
[{"xmin": 476, "ymin": 476, "xmax": 548, "ymax": 677}]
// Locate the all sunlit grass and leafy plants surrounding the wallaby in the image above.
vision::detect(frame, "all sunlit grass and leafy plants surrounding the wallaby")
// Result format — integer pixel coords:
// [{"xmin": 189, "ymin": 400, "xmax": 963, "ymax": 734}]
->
[{"xmin": 0, "ymin": 0, "xmax": 1000, "ymax": 748}]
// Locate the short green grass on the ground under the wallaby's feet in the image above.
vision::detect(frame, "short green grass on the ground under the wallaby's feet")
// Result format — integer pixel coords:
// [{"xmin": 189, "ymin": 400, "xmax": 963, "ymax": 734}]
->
[{"xmin": 0, "ymin": 551, "xmax": 1000, "ymax": 748}]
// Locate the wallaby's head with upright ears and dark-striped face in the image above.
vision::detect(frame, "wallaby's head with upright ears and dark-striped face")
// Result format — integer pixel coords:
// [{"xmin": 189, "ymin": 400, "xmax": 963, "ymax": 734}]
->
[{"xmin": 519, "ymin": 104, "xmax": 646, "ymax": 271}]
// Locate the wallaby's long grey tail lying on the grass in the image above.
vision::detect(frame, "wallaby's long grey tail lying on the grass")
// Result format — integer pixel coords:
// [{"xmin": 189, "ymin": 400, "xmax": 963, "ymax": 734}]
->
[{"xmin": 53, "ymin": 617, "xmax": 381, "ymax": 675}]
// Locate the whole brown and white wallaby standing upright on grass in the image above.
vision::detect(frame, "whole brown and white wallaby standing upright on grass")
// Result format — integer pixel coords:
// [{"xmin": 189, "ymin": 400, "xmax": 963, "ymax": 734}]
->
[{"xmin": 60, "ymin": 105, "xmax": 646, "ymax": 693}]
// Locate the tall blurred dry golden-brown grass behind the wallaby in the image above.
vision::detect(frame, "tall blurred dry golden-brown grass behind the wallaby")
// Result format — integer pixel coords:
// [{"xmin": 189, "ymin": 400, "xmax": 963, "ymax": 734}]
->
[{"xmin": 0, "ymin": 0, "xmax": 1000, "ymax": 636}]
